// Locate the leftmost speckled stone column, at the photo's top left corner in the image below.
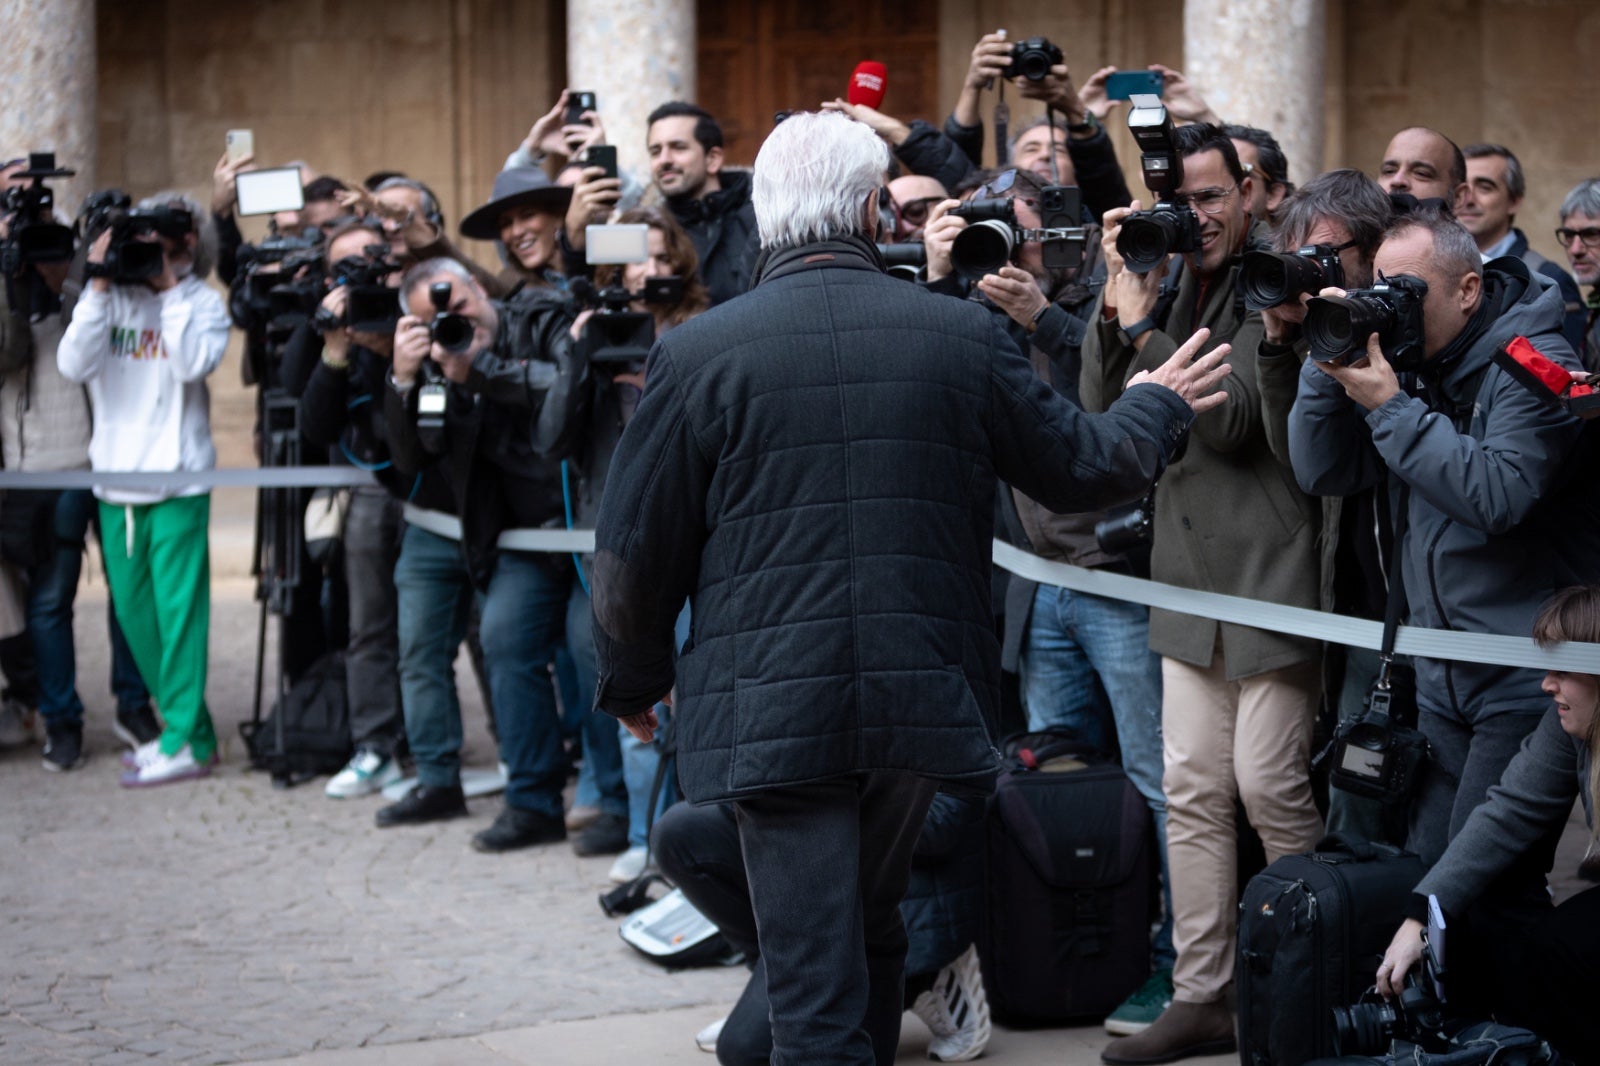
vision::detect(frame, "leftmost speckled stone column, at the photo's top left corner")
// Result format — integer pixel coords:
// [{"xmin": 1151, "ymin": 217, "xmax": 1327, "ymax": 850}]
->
[{"xmin": 0, "ymin": 0, "xmax": 99, "ymax": 218}]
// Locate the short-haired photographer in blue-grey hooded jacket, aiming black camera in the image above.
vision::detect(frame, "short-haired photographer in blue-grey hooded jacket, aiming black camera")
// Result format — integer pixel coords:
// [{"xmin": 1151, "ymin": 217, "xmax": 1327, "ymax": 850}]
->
[{"xmin": 1290, "ymin": 208, "xmax": 1600, "ymax": 916}]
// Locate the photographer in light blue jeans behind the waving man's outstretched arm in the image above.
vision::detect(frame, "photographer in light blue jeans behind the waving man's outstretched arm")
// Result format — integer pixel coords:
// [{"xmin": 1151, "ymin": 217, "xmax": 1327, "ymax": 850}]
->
[{"xmin": 926, "ymin": 160, "xmax": 1173, "ymax": 1036}]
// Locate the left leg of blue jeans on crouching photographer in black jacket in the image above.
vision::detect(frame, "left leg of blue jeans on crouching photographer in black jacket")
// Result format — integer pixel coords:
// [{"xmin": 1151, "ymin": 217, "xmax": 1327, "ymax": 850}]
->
[{"xmin": 395, "ymin": 525, "xmax": 472, "ymax": 787}]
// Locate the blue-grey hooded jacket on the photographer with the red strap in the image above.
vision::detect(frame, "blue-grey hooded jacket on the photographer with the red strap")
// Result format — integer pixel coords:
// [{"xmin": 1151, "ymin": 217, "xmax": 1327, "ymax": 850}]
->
[{"xmin": 1290, "ymin": 256, "xmax": 1594, "ymax": 710}]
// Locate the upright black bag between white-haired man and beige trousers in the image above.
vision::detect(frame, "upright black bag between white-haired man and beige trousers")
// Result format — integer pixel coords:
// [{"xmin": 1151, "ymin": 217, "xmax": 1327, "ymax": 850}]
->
[{"xmin": 978, "ymin": 733, "xmax": 1155, "ymax": 1024}]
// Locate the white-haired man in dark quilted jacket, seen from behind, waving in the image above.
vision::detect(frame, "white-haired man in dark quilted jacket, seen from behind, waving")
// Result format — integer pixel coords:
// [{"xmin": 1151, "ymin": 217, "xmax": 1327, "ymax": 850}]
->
[{"xmin": 594, "ymin": 114, "xmax": 1227, "ymax": 1066}]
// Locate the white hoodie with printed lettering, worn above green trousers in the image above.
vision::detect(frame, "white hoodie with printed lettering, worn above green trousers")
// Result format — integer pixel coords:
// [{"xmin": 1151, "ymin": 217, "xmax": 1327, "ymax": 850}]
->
[{"xmin": 56, "ymin": 274, "xmax": 230, "ymax": 504}]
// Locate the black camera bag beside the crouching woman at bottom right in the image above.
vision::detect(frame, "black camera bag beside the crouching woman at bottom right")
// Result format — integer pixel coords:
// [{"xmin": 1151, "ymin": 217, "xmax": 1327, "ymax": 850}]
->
[{"xmin": 1234, "ymin": 836, "xmax": 1424, "ymax": 1066}]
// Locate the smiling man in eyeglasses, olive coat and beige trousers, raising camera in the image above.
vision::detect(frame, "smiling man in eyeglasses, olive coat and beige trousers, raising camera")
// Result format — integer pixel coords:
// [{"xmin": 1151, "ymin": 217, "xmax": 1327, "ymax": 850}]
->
[{"xmin": 1080, "ymin": 123, "xmax": 1322, "ymax": 1063}]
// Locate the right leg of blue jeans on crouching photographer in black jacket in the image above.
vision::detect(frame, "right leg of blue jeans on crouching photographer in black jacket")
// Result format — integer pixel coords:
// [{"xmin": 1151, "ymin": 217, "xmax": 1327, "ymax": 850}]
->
[{"xmin": 478, "ymin": 551, "xmax": 570, "ymax": 818}]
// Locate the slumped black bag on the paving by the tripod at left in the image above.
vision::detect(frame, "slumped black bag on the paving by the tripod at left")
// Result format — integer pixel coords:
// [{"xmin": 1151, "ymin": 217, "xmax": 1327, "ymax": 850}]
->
[{"xmin": 238, "ymin": 651, "xmax": 354, "ymax": 784}]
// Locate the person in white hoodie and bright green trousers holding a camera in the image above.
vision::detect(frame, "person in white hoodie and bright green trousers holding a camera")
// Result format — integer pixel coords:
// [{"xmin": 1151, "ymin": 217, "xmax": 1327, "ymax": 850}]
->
[{"xmin": 58, "ymin": 195, "xmax": 229, "ymax": 787}]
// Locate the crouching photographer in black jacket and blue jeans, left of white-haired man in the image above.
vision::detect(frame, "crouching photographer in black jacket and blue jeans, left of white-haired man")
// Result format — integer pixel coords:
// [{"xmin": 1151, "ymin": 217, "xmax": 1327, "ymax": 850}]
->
[{"xmin": 378, "ymin": 259, "xmax": 626, "ymax": 855}]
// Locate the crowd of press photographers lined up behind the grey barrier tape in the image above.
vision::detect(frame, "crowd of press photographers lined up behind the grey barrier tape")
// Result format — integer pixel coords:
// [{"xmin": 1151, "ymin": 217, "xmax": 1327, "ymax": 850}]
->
[{"xmin": 0, "ymin": 22, "xmax": 1600, "ymax": 1063}]
